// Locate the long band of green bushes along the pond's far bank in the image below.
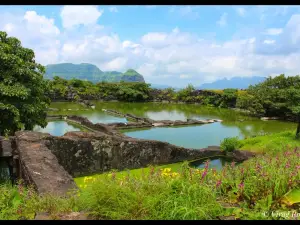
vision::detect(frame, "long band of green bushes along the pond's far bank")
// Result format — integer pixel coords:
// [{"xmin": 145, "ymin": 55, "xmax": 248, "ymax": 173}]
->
[{"xmin": 48, "ymin": 76, "xmax": 238, "ymax": 108}]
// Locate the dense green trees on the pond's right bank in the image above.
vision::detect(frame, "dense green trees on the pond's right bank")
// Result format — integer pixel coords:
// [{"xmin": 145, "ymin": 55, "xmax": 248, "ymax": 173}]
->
[{"xmin": 237, "ymin": 74, "xmax": 300, "ymax": 136}]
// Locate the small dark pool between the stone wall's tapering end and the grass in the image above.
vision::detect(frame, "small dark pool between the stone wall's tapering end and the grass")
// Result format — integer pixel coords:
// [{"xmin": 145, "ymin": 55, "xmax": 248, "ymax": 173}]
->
[{"xmin": 189, "ymin": 157, "xmax": 240, "ymax": 171}]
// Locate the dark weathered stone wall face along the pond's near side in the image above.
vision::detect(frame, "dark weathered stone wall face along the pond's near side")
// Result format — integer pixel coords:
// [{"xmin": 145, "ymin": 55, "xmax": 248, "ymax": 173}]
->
[{"xmin": 45, "ymin": 132, "xmax": 253, "ymax": 176}]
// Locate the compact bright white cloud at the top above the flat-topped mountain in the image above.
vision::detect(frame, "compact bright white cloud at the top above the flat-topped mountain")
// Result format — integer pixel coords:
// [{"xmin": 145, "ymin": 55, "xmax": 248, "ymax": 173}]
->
[{"xmin": 60, "ymin": 5, "xmax": 103, "ymax": 28}]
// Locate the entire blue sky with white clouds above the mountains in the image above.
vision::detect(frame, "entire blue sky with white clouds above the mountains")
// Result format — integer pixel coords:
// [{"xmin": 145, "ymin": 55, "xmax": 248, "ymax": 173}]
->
[{"xmin": 0, "ymin": 5, "xmax": 300, "ymax": 87}]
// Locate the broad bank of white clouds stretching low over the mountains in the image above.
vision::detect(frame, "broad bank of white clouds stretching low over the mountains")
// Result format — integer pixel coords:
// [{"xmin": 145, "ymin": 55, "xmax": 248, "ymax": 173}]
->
[{"xmin": 0, "ymin": 8, "xmax": 300, "ymax": 86}]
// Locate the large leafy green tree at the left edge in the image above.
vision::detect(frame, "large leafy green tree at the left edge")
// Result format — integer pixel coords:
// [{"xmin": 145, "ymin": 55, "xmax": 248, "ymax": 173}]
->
[{"xmin": 0, "ymin": 32, "xmax": 50, "ymax": 135}]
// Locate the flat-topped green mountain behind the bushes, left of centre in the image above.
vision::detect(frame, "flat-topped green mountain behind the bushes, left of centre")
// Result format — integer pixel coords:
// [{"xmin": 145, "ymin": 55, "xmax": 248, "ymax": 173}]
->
[{"xmin": 45, "ymin": 63, "xmax": 145, "ymax": 83}]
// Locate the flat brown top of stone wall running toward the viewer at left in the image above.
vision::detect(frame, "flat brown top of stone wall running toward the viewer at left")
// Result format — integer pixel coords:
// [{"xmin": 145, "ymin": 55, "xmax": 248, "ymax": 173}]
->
[{"xmin": 16, "ymin": 131, "xmax": 77, "ymax": 195}]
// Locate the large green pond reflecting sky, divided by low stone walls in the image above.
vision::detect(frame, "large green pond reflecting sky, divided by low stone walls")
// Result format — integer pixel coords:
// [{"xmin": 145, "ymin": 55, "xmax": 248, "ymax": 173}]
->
[{"xmin": 42, "ymin": 101, "xmax": 296, "ymax": 148}]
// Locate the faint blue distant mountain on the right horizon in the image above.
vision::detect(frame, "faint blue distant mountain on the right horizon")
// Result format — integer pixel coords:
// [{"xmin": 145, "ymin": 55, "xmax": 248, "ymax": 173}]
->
[{"xmin": 197, "ymin": 76, "xmax": 266, "ymax": 89}]
